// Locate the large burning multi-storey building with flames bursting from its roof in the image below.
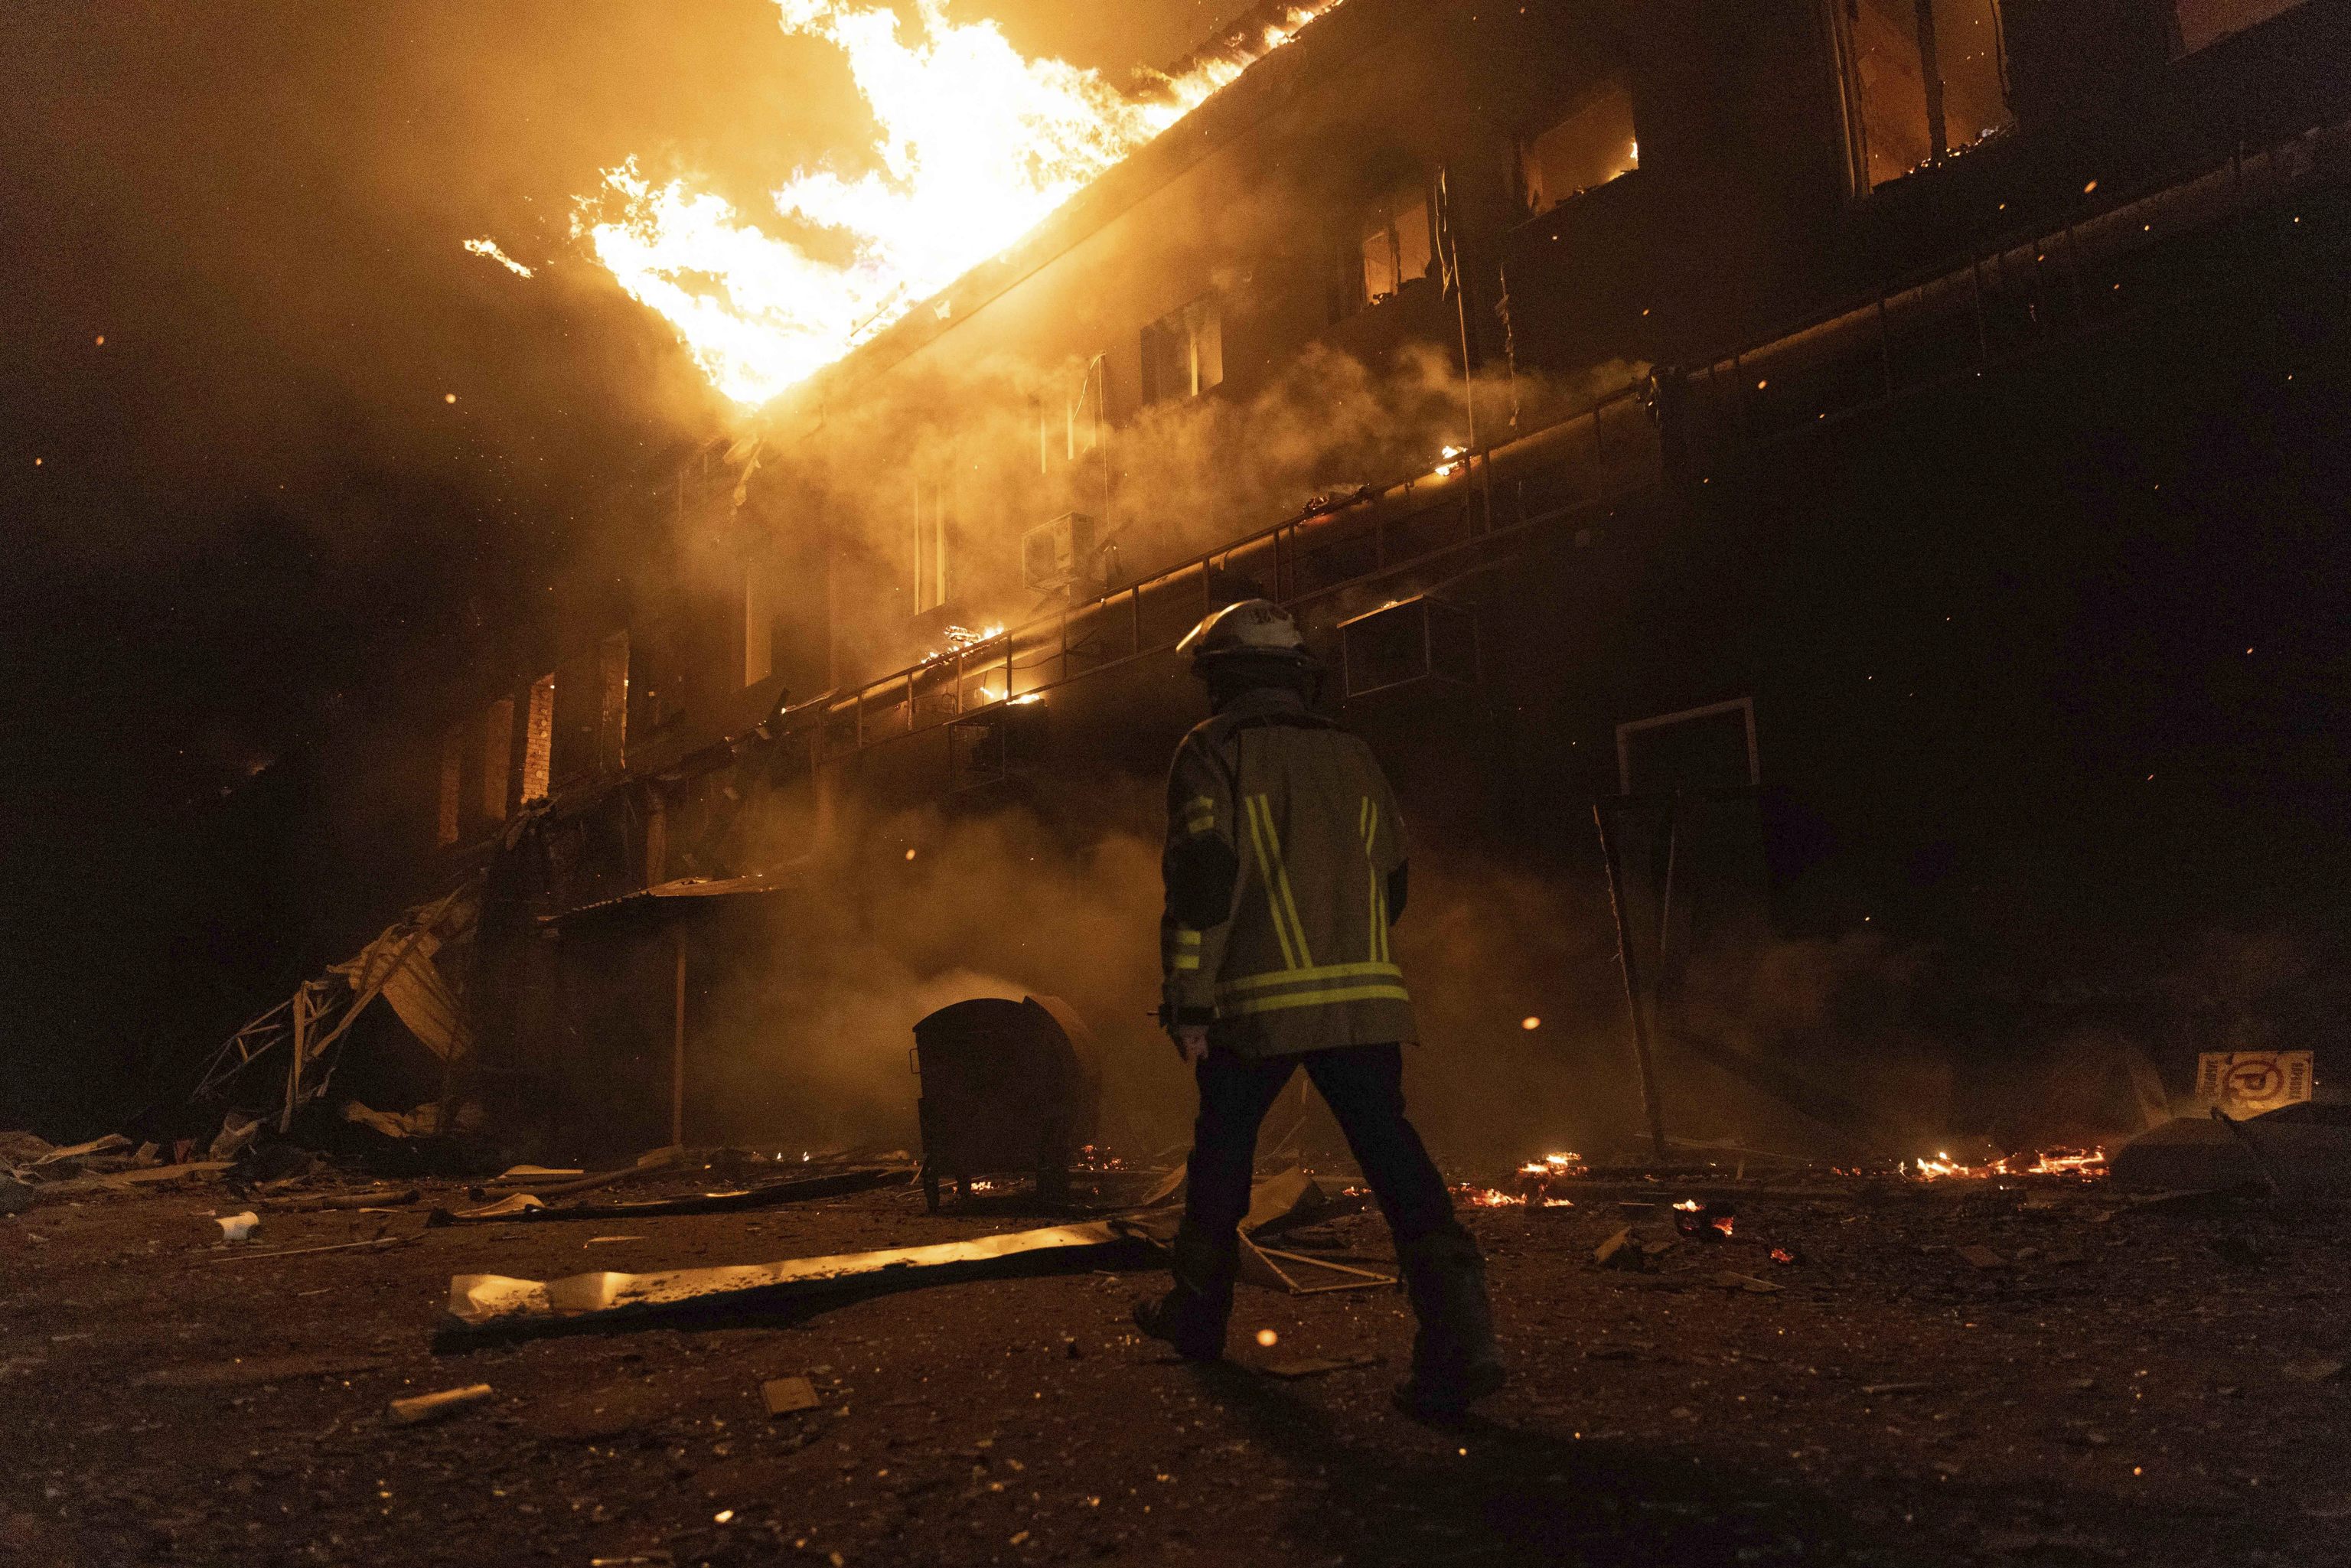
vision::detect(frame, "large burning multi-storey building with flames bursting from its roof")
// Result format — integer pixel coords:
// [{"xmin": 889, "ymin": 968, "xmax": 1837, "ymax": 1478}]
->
[{"xmin": 331, "ymin": 0, "xmax": 2351, "ymax": 1165}]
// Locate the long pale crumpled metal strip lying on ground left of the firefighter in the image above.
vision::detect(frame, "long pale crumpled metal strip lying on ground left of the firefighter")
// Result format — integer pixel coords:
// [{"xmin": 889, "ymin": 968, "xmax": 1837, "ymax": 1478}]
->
[{"xmin": 449, "ymin": 1220, "xmax": 1149, "ymax": 1331}]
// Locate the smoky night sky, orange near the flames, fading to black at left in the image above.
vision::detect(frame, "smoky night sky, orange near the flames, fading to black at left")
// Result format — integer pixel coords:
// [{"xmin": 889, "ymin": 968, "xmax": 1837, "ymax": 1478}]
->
[{"xmin": 0, "ymin": 0, "xmax": 1239, "ymax": 1133}]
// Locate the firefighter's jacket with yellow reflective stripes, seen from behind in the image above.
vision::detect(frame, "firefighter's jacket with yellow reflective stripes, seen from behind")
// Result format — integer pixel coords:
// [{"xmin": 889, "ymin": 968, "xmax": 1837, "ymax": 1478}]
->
[{"xmin": 1159, "ymin": 691, "xmax": 1415, "ymax": 1055}]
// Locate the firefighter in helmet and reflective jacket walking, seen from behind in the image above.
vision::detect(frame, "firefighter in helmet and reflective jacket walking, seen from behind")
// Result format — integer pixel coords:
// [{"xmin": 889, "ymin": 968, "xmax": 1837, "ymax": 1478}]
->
[{"xmin": 1136, "ymin": 599, "xmax": 1502, "ymax": 1417}]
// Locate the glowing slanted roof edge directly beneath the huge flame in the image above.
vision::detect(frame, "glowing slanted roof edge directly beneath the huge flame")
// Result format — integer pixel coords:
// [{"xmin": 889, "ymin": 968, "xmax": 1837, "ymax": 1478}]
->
[{"xmin": 766, "ymin": 0, "xmax": 1425, "ymax": 414}]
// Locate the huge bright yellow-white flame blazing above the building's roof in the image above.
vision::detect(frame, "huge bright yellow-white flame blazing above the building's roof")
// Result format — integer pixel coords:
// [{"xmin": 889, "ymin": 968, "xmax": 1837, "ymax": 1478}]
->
[{"xmin": 574, "ymin": 0, "xmax": 1340, "ymax": 406}]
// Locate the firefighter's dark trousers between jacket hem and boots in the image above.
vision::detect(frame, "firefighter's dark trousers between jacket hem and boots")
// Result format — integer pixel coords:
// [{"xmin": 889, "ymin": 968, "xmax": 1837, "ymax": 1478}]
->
[{"xmin": 1185, "ymin": 1046, "xmax": 1460, "ymax": 1246}]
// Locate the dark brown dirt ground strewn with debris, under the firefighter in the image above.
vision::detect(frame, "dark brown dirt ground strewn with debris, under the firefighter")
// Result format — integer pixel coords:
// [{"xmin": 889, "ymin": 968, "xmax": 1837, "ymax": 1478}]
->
[{"xmin": 0, "ymin": 1165, "xmax": 2351, "ymax": 1568}]
